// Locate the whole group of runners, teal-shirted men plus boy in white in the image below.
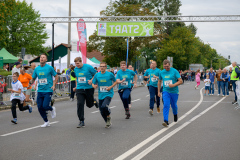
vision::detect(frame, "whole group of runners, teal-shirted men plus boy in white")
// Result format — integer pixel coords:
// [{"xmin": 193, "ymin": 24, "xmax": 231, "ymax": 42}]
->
[{"xmin": 9, "ymin": 54, "xmax": 182, "ymax": 128}]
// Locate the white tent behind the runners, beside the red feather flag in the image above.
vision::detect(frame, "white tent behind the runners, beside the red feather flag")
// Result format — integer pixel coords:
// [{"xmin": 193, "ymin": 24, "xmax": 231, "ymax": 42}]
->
[{"xmin": 47, "ymin": 51, "xmax": 99, "ymax": 71}]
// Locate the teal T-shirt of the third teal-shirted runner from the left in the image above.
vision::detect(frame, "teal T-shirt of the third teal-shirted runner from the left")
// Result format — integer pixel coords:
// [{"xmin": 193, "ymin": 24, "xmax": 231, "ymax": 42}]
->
[{"xmin": 93, "ymin": 71, "xmax": 116, "ymax": 100}]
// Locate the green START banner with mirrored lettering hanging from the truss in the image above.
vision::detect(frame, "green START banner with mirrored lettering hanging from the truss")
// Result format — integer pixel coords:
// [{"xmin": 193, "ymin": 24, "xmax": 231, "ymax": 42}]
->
[{"xmin": 97, "ymin": 22, "xmax": 154, "ymax": 37}]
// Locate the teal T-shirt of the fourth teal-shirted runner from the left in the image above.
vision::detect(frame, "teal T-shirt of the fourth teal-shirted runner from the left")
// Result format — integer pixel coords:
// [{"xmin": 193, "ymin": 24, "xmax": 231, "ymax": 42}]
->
[{"xmin": 116, "ymin": 69, "xmax": 136, "ymax": 90}]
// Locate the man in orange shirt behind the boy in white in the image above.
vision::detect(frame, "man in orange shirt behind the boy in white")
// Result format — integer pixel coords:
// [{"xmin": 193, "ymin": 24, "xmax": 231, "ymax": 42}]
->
[{"xmin": 18, "ymin": 68, "xmax": 34, "ymax": 105}]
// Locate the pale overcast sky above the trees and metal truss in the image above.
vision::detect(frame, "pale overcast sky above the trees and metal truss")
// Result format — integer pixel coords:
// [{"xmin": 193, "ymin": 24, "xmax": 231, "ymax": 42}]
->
[{"xmin": 21, "ymin": 0, "xmax": 240, "ymax": 63}]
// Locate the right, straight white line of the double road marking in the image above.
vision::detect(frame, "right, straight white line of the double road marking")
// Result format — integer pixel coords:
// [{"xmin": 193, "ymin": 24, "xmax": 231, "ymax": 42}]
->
[{"xmin": 132, "ymin": 97, "xmax": 226, "ymax": 160}]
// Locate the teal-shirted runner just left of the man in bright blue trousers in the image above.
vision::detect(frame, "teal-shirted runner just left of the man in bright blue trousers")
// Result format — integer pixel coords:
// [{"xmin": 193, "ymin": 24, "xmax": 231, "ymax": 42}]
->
[{"xmin": 144, "ymin": 61, "xmax": 161, "ymax": 115}]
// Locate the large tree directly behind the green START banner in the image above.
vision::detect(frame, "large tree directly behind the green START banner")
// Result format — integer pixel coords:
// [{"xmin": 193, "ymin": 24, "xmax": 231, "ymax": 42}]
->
[{"xmin": 88, "ymin": 0, "xmax": 163, "ymax": 66}]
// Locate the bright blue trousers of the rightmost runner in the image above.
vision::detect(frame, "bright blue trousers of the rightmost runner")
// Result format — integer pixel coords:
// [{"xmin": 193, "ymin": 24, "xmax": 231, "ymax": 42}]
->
[{"xmin": 162, "ymin": 91, "xmax": 178, "ymax": 121}]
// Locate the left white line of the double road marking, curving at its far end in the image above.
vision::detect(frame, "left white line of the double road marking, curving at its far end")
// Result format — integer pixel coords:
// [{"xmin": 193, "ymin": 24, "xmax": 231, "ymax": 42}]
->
[{"xmin": 115, "ymin": 88, "xmax": 203, "ymax": 160}]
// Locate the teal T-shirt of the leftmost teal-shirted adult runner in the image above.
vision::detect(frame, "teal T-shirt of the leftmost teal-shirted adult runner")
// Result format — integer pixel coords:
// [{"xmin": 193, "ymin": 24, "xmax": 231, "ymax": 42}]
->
[{"xmin": 32, "ymin": 64, "xmax": 57, "ymax": 92}]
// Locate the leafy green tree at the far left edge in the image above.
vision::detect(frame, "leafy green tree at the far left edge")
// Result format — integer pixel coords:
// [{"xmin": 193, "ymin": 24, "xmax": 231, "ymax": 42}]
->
[{"xmin": 0, "ymin": 0, "xmax": 48, "ymax": 55}]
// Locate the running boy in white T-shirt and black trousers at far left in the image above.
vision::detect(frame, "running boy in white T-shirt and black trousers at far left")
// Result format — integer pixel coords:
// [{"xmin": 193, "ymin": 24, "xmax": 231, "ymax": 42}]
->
[{"xmin": 8, "ymin": 72, "xmax": 32, "ymax": 124}]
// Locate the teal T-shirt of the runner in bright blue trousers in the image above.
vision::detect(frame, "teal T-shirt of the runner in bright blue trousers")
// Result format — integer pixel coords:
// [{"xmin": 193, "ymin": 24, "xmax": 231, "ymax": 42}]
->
[{"xmin": 159, "ymin": 68, "xmax": 181, "ymax": 94}]
